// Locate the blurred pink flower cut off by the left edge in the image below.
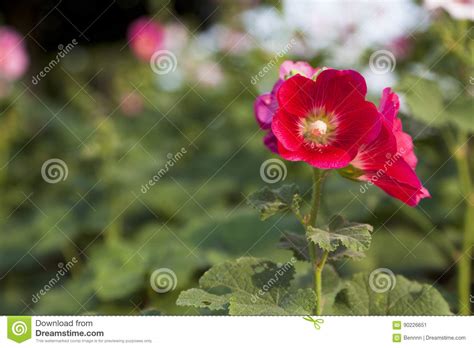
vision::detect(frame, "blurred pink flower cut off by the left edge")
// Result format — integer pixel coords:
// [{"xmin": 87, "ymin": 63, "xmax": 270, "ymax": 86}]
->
[{"xmin": 0, "ymin": 26, "xmax": 30, "ymax": 81}]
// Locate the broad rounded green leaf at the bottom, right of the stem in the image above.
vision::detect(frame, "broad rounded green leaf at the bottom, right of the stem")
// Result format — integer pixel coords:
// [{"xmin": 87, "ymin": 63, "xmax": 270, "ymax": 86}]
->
[{"xmin": 330, "ymin": 271, "xmax": 452, "ymax": 315}]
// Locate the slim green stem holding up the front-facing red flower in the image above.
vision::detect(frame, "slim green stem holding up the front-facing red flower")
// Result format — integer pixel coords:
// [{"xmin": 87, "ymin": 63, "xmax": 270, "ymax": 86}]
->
[{"xmin": 308, "ymin": 168, "xmax": 328, "ymax": 315}]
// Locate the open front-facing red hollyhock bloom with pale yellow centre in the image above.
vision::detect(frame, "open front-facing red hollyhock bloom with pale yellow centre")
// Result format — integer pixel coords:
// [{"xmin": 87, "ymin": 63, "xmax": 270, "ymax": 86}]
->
[{"xmin": 271, "ymin": 69, "xmax": 381, "ymax": 169}]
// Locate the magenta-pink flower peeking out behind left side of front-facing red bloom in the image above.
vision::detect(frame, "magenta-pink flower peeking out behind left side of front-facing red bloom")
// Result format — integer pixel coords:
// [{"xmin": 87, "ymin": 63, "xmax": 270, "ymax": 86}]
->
[{"xmin": 254, "ymin": 60, "xmax": 319, "ymax": 153}]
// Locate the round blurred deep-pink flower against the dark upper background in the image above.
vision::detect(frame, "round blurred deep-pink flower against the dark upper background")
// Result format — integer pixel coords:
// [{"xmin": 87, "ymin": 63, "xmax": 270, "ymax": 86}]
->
[{"xmin": 127, "ymin": 17, "xmax": 165, "ymax": 60}]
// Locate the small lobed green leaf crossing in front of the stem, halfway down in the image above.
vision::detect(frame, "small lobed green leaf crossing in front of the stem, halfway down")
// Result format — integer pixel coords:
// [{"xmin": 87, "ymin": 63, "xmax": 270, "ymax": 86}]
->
[{"xmin": 307, "ymin": 216, "xmax": 373, "ymax": 253}]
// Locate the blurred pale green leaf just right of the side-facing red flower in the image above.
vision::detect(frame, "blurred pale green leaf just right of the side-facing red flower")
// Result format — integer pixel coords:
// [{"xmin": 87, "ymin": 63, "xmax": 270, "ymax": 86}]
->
[{"xmin": 400, "ymin": 75, "xmax": 448, "ymax": 126}]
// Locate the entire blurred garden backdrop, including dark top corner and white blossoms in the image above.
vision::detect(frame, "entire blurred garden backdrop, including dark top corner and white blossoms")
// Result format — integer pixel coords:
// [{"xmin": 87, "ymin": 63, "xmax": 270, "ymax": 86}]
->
[{"xmin": 0, "ymin": 0, "xmax": 474, "ymax": 315}]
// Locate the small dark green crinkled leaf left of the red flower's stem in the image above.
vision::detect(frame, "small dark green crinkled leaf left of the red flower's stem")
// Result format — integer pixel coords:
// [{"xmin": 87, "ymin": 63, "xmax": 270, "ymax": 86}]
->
[{"xmin": 249, "ymin": 184, "xmax": 301, "ymax": 220}]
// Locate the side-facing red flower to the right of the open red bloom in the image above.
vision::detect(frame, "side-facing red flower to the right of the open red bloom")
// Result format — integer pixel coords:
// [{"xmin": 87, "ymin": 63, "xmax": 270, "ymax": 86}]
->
[{"xmin": 351, "ymin": 88, "xmax": 431, "ymax": 206}]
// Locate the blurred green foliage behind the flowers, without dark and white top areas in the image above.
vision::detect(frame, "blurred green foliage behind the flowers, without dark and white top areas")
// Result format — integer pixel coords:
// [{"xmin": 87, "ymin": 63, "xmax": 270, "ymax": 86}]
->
[{"xmin": 0, "ymin": 0, "xmax": 474, "ymax": 315}]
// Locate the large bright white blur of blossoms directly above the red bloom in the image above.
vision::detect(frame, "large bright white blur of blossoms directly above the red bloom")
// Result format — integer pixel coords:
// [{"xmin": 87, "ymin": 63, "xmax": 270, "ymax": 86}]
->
[{"xmin": 283, "ymin": 0, "xmax": 429, "ymax": 67}]
